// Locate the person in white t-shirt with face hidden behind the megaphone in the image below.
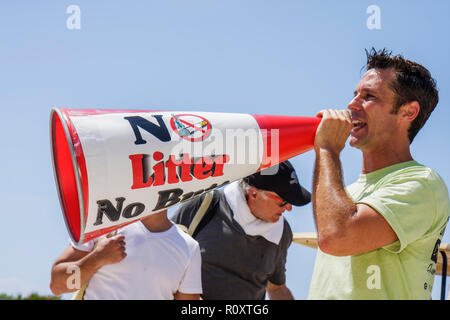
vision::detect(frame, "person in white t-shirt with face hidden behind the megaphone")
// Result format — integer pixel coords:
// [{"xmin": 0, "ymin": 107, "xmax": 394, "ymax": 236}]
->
[{"xmin": 50, "ymin": 211, "xmax": 202, "ymax": 300}]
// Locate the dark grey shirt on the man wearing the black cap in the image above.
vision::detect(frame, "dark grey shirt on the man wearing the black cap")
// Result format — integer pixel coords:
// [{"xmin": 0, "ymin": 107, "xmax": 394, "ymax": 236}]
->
[{"xmin": 172, "ymin": 190, "xmax": 292, "ymax": 300}]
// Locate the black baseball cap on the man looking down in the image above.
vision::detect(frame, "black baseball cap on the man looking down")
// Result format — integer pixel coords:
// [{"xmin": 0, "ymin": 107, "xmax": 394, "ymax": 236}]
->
[{"xmin": 244, "ymin": 160, "xmax": 311, "ymax": 206}]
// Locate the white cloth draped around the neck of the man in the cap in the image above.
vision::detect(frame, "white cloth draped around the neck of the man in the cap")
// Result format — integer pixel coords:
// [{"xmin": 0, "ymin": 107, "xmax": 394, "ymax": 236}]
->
[{"xmin": 223, "ymin": 181, "xmax": 284, "ymax": 245}]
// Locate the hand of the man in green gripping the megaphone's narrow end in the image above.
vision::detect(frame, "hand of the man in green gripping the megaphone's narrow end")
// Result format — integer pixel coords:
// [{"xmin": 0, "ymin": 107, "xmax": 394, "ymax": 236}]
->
[{"xmin": 314, "ymin": 109, "xmax": 353, "ymax": 154}]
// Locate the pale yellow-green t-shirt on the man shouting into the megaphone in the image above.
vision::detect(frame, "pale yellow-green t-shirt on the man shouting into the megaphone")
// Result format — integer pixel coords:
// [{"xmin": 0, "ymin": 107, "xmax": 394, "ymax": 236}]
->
[{"xmin": 308, "ymin": 161, "xmax": 449, "ymax": 300}]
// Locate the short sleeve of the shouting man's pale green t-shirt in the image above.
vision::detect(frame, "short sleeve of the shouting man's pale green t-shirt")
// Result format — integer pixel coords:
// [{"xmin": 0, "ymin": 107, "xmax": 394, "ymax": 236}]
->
[{"xmin": 357, "ymin": 170, "xmax": 436, "ymax": 252}]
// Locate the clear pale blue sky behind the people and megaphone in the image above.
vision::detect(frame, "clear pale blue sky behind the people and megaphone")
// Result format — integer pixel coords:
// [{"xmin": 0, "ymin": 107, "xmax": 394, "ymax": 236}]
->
[{"xmin": 0, "ymin": 0, "xmax": 450, "ymax": 299}]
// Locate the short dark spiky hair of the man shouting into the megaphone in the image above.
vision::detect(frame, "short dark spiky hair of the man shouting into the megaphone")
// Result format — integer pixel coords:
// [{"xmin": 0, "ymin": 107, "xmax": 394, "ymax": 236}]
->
[{"xmin": 365, "ymin": 48, "xmax": 439, "ymax": 143}]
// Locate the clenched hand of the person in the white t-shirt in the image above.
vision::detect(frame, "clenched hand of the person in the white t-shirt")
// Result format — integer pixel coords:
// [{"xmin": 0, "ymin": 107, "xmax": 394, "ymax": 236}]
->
[{"xmin": 93, "ymin": 234, "xmax": 127, "ymax": 265}]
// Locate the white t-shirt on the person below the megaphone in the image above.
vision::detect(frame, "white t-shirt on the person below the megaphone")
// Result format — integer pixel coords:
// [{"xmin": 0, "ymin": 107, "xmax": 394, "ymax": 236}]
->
[{"xmin": 72, "ymin": 221, "xmax": 202, "ymax": 300}]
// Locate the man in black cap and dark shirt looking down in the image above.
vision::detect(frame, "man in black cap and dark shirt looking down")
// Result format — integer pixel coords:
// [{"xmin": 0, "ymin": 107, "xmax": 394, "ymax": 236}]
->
[{"xmin": 172, "ymin": 161, "xmax": 311, "ymax": 300}]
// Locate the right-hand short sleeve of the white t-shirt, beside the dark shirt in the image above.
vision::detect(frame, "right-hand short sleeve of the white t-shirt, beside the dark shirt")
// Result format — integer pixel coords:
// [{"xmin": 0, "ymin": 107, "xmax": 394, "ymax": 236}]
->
[{"xmin": 178, "ymin": 243, "xmax": 203, "ymax": 294}]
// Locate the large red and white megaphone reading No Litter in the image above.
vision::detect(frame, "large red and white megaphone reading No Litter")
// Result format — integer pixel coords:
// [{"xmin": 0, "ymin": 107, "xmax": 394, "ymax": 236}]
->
[{"xmin": 50, "ymin": 109, "xmax": 320, "ymax": 244}]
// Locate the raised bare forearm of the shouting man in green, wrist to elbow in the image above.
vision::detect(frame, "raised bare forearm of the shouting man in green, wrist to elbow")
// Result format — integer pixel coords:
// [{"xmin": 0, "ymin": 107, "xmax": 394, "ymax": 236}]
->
[{"xmin": 312, "ymin": 149, "xmax": 356, "ymax": 248}]
